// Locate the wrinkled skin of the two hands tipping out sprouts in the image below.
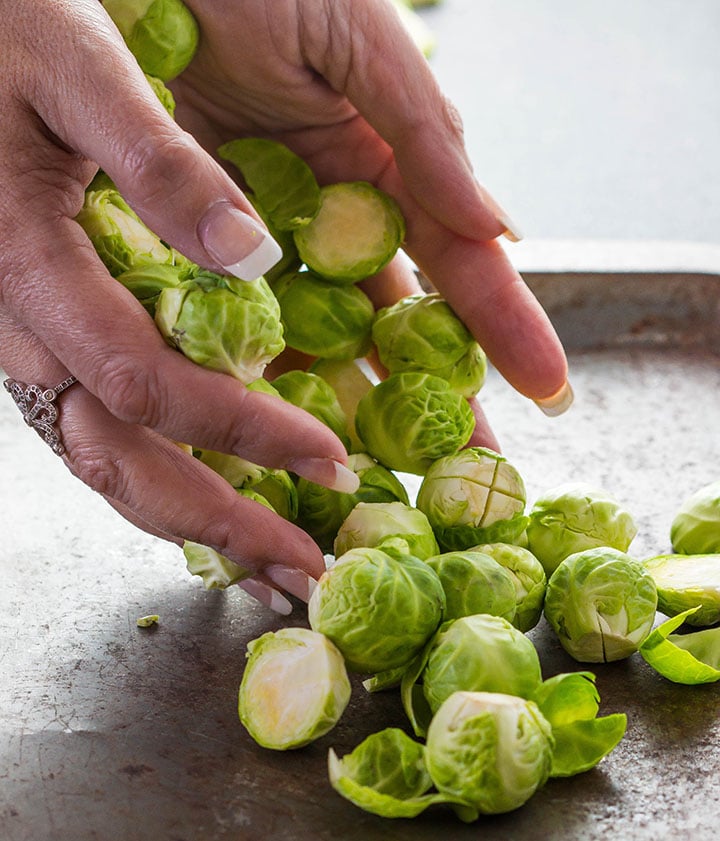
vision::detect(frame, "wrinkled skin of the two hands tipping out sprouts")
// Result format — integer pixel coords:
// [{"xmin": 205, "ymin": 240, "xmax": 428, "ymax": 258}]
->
[{"xmin": 0, "ymin": 0, "xmax": 567, "ymax": 602}]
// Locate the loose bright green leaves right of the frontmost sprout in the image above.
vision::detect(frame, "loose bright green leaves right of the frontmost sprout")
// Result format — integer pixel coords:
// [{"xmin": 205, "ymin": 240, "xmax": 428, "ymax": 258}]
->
[{"xmin": 533, "ymin": 672, "xmax": 627, "ymax": 777}]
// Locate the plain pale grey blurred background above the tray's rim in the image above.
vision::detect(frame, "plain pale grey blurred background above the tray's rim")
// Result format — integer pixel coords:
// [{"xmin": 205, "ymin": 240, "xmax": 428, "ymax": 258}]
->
[{"xmin": 418, "ymin": 0, "xmax": 720, "ymax": 249}]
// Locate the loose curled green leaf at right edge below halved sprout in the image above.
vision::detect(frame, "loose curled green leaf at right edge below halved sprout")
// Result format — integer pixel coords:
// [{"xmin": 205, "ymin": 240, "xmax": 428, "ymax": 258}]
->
[{"xmin": 640, "ymin": 608, "xmax": 720, "ymax": 686}]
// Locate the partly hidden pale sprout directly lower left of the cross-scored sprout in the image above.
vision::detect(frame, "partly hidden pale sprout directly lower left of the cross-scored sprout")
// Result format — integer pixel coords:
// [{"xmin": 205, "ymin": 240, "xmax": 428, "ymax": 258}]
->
[{"xmin": 334, "ymin": 500, "xmax": 439, "ymax": 560}]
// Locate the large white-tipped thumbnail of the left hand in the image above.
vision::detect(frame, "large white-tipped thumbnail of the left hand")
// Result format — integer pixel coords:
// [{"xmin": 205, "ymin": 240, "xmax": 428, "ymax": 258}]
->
[{"xmin": 198, "ymin": 201, "xmax": 282, "ymax": 280}]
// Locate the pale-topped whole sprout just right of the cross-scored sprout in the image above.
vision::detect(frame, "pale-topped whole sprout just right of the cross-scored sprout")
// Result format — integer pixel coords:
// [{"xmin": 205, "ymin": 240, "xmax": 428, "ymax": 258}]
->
[{"xmin": 526, "ymin": 482, "xmax": 637, "ymax": 575}]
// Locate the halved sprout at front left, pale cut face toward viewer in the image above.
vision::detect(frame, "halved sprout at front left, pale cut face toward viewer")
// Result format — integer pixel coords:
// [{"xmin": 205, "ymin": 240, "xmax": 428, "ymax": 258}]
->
[{"xmin": 238, "ymin": 628, "xmax": 351, "ymax": 750}]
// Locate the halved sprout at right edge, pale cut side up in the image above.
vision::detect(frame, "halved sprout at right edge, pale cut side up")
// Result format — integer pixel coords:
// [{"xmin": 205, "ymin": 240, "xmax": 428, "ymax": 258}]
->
[{"xmin": 643, "ymin": 554, "xmax": 720, "ymax": 626}]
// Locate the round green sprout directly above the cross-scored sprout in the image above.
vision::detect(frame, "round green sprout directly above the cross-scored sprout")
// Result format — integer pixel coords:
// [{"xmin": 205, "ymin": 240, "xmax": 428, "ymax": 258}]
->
[{"xmin": 355, "ymin": 373, "xmax": 477, "ymax": 476}]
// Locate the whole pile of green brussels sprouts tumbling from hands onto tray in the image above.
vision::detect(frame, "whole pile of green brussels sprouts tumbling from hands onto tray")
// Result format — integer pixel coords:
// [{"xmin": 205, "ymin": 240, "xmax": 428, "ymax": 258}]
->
[{"xmin": 91, "ymin": 0, "xmax": 720, "ymax": 821}]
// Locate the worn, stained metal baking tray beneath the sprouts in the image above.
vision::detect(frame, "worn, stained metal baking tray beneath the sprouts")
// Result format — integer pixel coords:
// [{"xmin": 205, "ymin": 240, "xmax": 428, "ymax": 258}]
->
[{"xmin": 0, "ymin": 272, "xmax": 720, "ymax": 841}]
